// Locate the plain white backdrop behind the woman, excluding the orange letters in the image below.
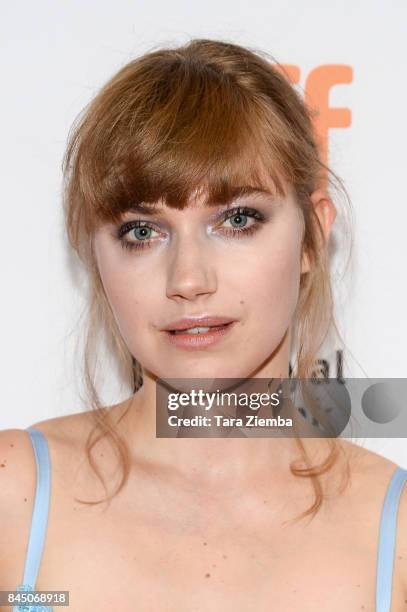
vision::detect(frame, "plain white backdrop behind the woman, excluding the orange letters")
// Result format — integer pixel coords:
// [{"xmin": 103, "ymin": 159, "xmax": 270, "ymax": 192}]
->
[{"xmin": 0, "ymin": 0, "xmax": 407, "ymax": 467}]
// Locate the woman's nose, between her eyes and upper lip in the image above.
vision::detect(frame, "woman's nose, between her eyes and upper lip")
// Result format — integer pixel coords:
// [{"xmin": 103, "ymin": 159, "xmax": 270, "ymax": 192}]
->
[{"xmin": 166, "ymin": 235, "xmax": 217, "ymax": 301}]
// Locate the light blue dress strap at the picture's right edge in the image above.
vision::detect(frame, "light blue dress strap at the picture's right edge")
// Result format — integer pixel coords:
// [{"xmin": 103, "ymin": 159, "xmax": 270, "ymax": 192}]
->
[{"xmin": 376, "ymin": 466, "xmax": 407, "ymax": 612}]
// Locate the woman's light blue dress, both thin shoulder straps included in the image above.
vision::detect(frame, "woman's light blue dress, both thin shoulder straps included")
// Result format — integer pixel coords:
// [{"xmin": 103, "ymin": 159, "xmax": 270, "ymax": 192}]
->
[{"xmin": 13, "ymin": 427, "xmax": 407, "ymax": 612}]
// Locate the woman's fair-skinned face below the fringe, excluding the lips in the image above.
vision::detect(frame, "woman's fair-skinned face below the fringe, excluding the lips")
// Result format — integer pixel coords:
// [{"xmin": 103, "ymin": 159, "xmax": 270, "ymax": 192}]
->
[{"xmin": 94, "ymin": 184, "xmax": 305, "ymax": 378}]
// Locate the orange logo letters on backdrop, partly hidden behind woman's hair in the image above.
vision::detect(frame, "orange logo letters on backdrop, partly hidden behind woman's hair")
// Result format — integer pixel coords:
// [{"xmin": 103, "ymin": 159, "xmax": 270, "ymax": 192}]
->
[{"xmin": 275, "ymin": 64, "xmax": 353, "ymax": 173}]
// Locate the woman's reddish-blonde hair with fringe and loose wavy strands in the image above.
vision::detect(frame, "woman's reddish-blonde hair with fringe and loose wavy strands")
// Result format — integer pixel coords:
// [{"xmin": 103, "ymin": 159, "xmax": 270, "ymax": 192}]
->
[{"xmin": 63, "ymin": 39, "xmax": 349, "ymax": 518}]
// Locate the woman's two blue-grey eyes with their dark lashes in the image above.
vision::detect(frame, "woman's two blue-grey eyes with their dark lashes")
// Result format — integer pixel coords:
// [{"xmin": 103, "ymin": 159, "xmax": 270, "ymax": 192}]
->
[{"xmin": 113, "ymin": 206, "xmax": 266, "ymax": 251}]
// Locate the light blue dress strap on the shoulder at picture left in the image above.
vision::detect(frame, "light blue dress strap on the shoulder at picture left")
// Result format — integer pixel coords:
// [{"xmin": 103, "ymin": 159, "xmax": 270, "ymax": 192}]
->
[{"xmin": 13, "ymin": 427, "xmax": 52, "ymax": 612}]
